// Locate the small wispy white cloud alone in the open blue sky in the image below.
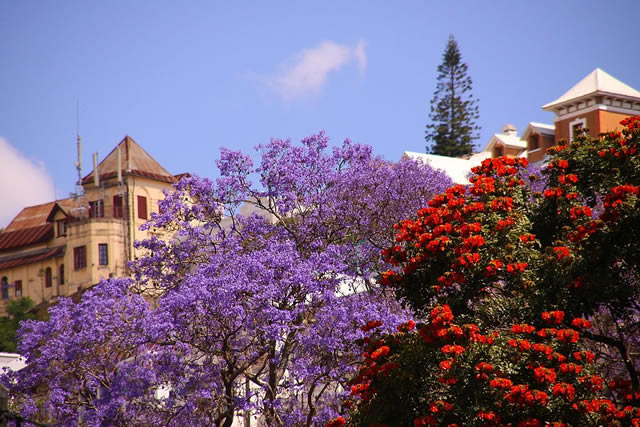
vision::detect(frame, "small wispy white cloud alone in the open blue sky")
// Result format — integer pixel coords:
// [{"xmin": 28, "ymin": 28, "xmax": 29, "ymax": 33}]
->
[{"xmin": 269, "ymin": 40, "xmax": 367, "ymax": 100}]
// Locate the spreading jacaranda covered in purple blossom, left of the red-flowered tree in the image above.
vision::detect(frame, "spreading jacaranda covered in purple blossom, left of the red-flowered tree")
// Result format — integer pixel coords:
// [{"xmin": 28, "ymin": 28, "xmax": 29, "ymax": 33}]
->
[{"xmin": 4, "ymin": 133, "xmax": 451, "ymax": 426}]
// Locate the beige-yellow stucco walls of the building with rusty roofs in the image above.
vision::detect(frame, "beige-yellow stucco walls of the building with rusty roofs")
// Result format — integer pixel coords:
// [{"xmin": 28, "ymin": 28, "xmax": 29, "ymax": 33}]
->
[{"xmin": 0, "ymin": 176, "xmax": 172, "ymax": 316}]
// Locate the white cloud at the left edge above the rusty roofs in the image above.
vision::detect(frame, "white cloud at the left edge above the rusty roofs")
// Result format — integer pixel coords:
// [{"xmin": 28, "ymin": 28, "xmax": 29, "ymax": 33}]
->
[{"xmin": 0, "ymin": 137, "xmax": 55, "ymax": 227}]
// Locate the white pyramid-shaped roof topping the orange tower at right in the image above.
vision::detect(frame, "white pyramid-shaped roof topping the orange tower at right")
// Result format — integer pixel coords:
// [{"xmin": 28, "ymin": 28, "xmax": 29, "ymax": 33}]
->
[{"xmin": 542, "ymin": 68, "xmax": 640, "ymax": 111}]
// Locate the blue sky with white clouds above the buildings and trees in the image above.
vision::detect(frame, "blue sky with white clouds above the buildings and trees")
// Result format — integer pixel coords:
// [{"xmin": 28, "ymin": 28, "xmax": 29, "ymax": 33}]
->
[{"xmin": 0, "ymin": 0, "xmax": 640, "ymax": 227}]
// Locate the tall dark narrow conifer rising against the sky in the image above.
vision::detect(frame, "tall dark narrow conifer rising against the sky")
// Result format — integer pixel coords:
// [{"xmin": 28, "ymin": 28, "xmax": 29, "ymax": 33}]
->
[{"xmin": 425, "ymin": 35, "xmax": 480, "ymax": 157}]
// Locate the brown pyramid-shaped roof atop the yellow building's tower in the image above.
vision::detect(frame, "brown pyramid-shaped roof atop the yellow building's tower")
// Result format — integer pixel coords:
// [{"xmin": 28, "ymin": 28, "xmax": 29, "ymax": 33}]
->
[{"xmin": 82, "ymin": 135, "xmax": 177, "ymax": 184}]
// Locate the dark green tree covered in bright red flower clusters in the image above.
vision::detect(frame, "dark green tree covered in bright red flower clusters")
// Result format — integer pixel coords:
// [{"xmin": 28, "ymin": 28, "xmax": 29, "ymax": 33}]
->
[{"xmin": 340, "ymin": 117, "xmax": 640, "ymax": 426}]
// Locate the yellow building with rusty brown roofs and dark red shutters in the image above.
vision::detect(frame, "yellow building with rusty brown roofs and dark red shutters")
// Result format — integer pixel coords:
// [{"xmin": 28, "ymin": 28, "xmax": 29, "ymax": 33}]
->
[{"xmin": 0, "ymin": 136, "xmax": 183, "ymax": 315}]
